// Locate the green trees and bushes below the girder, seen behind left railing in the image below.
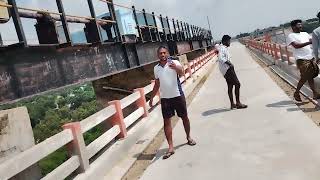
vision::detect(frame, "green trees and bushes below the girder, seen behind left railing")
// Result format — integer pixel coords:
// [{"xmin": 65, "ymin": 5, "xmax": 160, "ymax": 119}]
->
[{"xmin": 0, "ymin": 84, "xmax": 103, "ymax": 175}]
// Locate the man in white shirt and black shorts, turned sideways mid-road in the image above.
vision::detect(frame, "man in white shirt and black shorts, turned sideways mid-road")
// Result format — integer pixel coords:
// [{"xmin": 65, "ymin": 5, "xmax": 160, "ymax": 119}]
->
[{"xmin": 218, "ymin": 35, "xmax": 248, "ymax": 109}]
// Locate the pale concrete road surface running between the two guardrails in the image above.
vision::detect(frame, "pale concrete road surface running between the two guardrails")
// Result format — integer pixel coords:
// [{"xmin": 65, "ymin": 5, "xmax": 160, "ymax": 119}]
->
[{"xmin": 141, "ymin": 43, "xmax": 320, "ymax": 180}]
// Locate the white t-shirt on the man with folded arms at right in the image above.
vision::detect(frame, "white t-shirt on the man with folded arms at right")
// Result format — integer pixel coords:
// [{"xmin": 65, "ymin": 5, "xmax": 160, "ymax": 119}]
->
[{"xmin": 288, "ymin": 32, "xmax": 313, "ymax": 60}]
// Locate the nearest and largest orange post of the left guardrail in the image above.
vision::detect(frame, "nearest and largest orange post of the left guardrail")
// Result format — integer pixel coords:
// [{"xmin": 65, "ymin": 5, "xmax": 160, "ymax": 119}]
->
[{"xmin": 62, "ymin": 122, "xmax": 89, "ymax": 173}]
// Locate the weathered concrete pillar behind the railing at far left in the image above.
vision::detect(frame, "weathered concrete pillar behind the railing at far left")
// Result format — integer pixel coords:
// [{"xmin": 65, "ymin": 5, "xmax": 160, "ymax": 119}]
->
[{"xmin": 0, "ymin": 107, "xmax": 41, "ymax": 180}]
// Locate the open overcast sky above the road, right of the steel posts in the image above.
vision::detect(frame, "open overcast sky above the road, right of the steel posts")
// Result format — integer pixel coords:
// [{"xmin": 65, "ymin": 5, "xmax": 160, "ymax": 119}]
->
[{"xmin": 125, "ymin": 0, "xmax": 320, "ymax": 39}]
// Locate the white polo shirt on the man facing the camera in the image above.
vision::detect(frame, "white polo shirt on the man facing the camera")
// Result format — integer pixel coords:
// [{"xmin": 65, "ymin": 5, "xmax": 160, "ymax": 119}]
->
[{"xmin": 154, "ymin": 60, "xmax": 183, "ymax": 99}]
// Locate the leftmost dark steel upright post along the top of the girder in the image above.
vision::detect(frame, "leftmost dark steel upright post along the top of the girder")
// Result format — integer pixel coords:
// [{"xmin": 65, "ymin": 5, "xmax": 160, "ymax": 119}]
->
[{"xmin": 8, "ymin": 0, "xmax": 28, "ymax": 47}]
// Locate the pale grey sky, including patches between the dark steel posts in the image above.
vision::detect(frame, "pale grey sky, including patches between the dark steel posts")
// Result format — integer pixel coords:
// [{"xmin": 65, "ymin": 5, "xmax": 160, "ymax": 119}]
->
[{"xmin": 0, "ymin": 0, "xmax": 320, "ymax": 41}]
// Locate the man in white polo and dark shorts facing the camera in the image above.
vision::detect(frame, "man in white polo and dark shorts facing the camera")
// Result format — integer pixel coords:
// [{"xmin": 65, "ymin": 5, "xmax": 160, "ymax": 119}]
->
[{"xmin": 149, "ymin": 46, "xmax": 196, "ymax": 159}]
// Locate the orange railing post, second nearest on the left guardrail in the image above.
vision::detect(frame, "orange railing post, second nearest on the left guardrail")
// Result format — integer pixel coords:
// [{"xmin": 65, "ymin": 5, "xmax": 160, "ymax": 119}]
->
[{"xmin": 108, "ymin": 100, "xmax": 127, "ymax": 139}]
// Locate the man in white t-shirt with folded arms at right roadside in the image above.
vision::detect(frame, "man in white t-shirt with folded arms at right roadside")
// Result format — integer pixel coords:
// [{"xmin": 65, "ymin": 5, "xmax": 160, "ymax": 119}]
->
[{"xmin": 288, "ymin": 20, "xmax": 320, "ymax": 102}]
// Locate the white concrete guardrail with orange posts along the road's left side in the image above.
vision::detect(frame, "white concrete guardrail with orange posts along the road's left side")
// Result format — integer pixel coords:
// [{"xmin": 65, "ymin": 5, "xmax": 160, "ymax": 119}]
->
[{"xmin": 0, "ymin": 50, "xmax": 216, "ymax": 180}]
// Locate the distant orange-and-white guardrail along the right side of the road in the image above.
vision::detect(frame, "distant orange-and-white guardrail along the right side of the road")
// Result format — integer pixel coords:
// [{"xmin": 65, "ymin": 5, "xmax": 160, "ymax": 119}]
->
[{"xmin": 243, "ymin": 40, "xmax": 295, "ymax": 65}]
